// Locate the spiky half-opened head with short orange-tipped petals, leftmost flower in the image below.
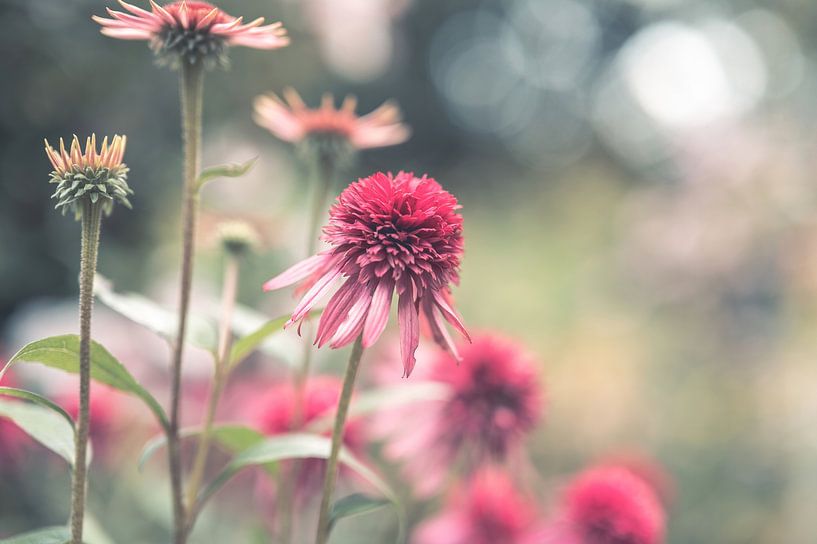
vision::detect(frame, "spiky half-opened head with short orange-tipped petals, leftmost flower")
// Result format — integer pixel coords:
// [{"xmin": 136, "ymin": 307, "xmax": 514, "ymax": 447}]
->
[{"xmin": 45, "ymin": 134, "xmax": 133, "ymax": 218}]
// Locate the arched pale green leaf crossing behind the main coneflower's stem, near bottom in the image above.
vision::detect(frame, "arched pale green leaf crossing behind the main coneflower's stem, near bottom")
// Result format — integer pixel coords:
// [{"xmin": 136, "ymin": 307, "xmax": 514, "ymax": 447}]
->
[{"xmin": 196, "ymin": 433, "xmax": 404, "ymax": 535}]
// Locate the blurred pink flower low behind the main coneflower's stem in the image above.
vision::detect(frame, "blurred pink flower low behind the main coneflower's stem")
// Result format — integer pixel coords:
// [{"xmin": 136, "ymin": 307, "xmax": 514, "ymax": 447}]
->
[{"xmin": 245, "ymin": 376, "xmax": 364, "ymax": 499}]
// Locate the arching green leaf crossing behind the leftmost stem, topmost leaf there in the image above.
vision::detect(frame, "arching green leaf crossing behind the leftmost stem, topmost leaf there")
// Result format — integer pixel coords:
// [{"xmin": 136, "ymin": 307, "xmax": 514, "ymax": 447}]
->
[{"xmin": 0, "ymin": 334, "xmax": 169, "ymax": 429}]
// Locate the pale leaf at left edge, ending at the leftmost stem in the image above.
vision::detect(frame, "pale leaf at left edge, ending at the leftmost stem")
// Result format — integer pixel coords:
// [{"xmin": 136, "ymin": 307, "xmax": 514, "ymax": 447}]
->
[{"xmin": 0, "ymin": 399, "xmax": 74, "ymax": 466}]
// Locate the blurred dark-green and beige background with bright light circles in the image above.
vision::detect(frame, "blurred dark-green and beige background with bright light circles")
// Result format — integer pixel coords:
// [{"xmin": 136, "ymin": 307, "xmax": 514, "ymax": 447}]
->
[{"xmin": 0, "ymin": 0, "xmax": 817, "ymax": 544}]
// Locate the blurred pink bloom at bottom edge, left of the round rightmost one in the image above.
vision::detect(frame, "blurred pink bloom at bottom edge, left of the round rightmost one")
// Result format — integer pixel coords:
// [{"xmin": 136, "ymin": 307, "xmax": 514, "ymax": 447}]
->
[{"xmin": 411, "ymin": 470, "xmax": 536, "ymax": 544}]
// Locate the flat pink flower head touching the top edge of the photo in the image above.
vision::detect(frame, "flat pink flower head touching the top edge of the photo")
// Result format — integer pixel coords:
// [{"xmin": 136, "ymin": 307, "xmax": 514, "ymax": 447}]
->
[{"xmin": 93, "ymin": 0, "xmax": 289, "ymax": 66}]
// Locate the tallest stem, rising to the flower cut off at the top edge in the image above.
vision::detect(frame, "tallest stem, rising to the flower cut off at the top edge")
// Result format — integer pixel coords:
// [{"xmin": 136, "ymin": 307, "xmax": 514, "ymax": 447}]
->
[{"xmin": 167, "ymin": 62, "xmax": 204, "ymax": 544}]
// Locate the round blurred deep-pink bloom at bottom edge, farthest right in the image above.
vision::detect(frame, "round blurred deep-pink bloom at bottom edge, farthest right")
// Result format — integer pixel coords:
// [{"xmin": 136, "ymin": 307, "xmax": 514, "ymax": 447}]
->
[{"xmin": 563, "ymin": 466, "xmax": 665, "ymax": 544}]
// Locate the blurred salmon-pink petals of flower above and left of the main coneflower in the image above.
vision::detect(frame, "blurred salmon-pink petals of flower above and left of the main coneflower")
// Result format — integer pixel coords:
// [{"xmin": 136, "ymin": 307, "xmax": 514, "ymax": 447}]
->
[{"xmin": 254, "ymin": 88, "xmax": 411, "ymax": 149}]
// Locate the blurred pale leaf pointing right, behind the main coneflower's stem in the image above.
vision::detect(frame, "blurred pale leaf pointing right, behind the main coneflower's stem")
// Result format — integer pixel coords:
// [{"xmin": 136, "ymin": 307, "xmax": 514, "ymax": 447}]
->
[{"xmin": 308, "ymin": 381, "xmax": 449, "ymax": 432}]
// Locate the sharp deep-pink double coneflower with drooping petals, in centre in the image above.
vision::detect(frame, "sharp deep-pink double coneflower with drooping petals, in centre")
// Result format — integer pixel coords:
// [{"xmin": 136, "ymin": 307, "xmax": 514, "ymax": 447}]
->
[{"xmin": 264, "ymin": 172, "xmax": 468, "ymax": 376}]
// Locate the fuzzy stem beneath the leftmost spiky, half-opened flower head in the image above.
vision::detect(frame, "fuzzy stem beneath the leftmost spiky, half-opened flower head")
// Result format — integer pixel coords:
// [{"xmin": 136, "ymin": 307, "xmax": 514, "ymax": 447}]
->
[{"xmin": 71, "ymin": 199, "xmax": 102, "ymax": 544}]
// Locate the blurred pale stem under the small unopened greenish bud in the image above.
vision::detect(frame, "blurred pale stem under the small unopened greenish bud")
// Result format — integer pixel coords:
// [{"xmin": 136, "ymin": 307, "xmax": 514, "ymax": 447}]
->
[{"xmin": 187, "ymin": 253, "xmax": 239, "ymax": 532}]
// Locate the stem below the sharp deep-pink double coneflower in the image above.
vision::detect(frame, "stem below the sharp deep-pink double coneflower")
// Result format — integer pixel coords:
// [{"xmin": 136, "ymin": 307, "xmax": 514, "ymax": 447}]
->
[{"xmin": 315, "ymin": 336, "xmax": 363, "ymax": 544}]
